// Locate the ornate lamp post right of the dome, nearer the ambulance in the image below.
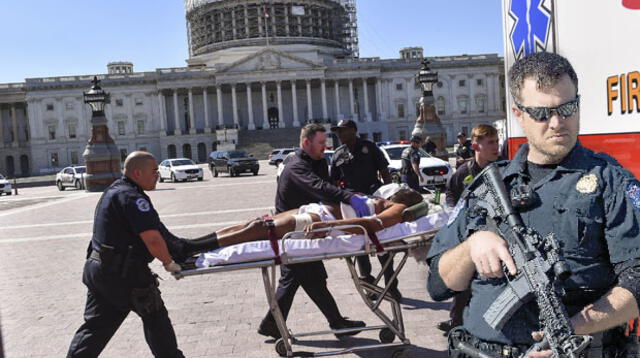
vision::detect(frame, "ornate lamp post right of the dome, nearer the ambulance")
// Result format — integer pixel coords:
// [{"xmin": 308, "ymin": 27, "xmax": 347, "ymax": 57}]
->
[{"xmin": 411, "ymin": 58, "xmax": 446, "ymax": 154}]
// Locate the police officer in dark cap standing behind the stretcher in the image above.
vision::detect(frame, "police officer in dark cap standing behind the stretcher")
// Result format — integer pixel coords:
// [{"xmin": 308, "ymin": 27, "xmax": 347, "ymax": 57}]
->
[{"xmin": 330, "ymin": 119, "xmax": 402, "ymax": 300}]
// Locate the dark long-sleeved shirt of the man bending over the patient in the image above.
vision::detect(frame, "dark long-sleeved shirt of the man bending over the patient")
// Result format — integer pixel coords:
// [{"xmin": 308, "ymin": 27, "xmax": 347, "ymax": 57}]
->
[{"xmin": 276, "ymin": 151, "xmax": 353, "ymax": 213}]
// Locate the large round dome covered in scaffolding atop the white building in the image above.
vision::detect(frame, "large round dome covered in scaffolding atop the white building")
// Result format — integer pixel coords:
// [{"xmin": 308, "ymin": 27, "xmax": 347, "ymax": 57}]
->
[{"xmin": 185, "ymin": 0, "xmax": 358, "ymax": 66}]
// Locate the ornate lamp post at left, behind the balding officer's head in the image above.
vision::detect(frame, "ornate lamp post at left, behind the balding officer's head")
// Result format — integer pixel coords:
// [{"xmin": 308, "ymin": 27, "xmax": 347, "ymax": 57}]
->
[{"xmin": 82, "ymin": 76, "xmax": 122, "ymax": 192}]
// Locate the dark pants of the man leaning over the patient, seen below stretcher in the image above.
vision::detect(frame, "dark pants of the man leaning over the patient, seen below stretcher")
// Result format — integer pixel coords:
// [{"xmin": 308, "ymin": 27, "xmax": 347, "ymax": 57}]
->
[{"xmin": 263, "ymin": 261, "xmax": 342, "ymax": 326}]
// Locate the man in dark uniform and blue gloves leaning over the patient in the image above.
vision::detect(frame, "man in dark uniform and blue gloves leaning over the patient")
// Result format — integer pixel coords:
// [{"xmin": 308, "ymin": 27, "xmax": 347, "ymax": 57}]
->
[{"xmin": 258, "ymin": 123, "xmax": 371, "ymax": 339}]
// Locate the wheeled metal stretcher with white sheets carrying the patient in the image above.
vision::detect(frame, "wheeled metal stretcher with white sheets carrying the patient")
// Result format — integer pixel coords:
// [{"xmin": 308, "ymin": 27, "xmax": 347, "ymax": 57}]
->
[{"xmin": 176, "ymin": 207, "xmax": 448, "ymax": 357}]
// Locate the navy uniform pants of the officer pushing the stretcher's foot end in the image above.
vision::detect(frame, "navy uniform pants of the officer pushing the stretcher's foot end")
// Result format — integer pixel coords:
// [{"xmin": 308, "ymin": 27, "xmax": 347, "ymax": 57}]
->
[{"xmin": 67, "ymin": 259, "xmax": 184, "ymax": 358}]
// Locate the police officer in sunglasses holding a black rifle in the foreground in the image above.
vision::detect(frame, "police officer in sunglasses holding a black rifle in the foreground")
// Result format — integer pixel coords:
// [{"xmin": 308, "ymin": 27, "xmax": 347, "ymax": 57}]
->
[{"xmin": 428, "ymin": 52, "xmax": 640, "ymax": 357}]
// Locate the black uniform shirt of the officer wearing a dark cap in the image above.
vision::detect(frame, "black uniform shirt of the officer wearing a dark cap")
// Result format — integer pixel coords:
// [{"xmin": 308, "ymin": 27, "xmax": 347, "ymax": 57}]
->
[{"xmin": 331, "ymin": 138, "xmax": 389, "ymax": 194}]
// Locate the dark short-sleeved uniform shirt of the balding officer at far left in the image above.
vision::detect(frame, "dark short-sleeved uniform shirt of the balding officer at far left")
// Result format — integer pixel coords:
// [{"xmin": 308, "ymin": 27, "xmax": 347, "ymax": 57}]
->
[{"xmin": 91, "ymin": 176, "xmax": 161, "ymax": 262}]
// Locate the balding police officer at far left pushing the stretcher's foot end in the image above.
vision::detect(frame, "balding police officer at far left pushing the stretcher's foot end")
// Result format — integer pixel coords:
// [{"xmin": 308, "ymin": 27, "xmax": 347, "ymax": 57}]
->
[{"xmin": 67, "ymin": 152, "xmax": 183, "ymax": 357}]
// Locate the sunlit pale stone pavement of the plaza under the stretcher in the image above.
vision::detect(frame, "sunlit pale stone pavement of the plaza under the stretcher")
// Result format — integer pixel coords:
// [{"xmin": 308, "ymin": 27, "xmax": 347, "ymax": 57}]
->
[{"xmin": 0, "ymin": 161, "xmax": 449, "ymax": 358}]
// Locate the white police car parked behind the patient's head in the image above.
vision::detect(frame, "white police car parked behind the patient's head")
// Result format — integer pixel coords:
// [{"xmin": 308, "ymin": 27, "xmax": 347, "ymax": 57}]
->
[{"xmin": 378, "ymin": 141, "xmax": 453, "ymax": 187}]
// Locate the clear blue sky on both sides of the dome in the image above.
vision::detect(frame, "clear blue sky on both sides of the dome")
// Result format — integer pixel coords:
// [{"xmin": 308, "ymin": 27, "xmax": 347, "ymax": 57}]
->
[{"xmin": 0, "ymin": 0, "xmax": 504, "ymax": 83}]
